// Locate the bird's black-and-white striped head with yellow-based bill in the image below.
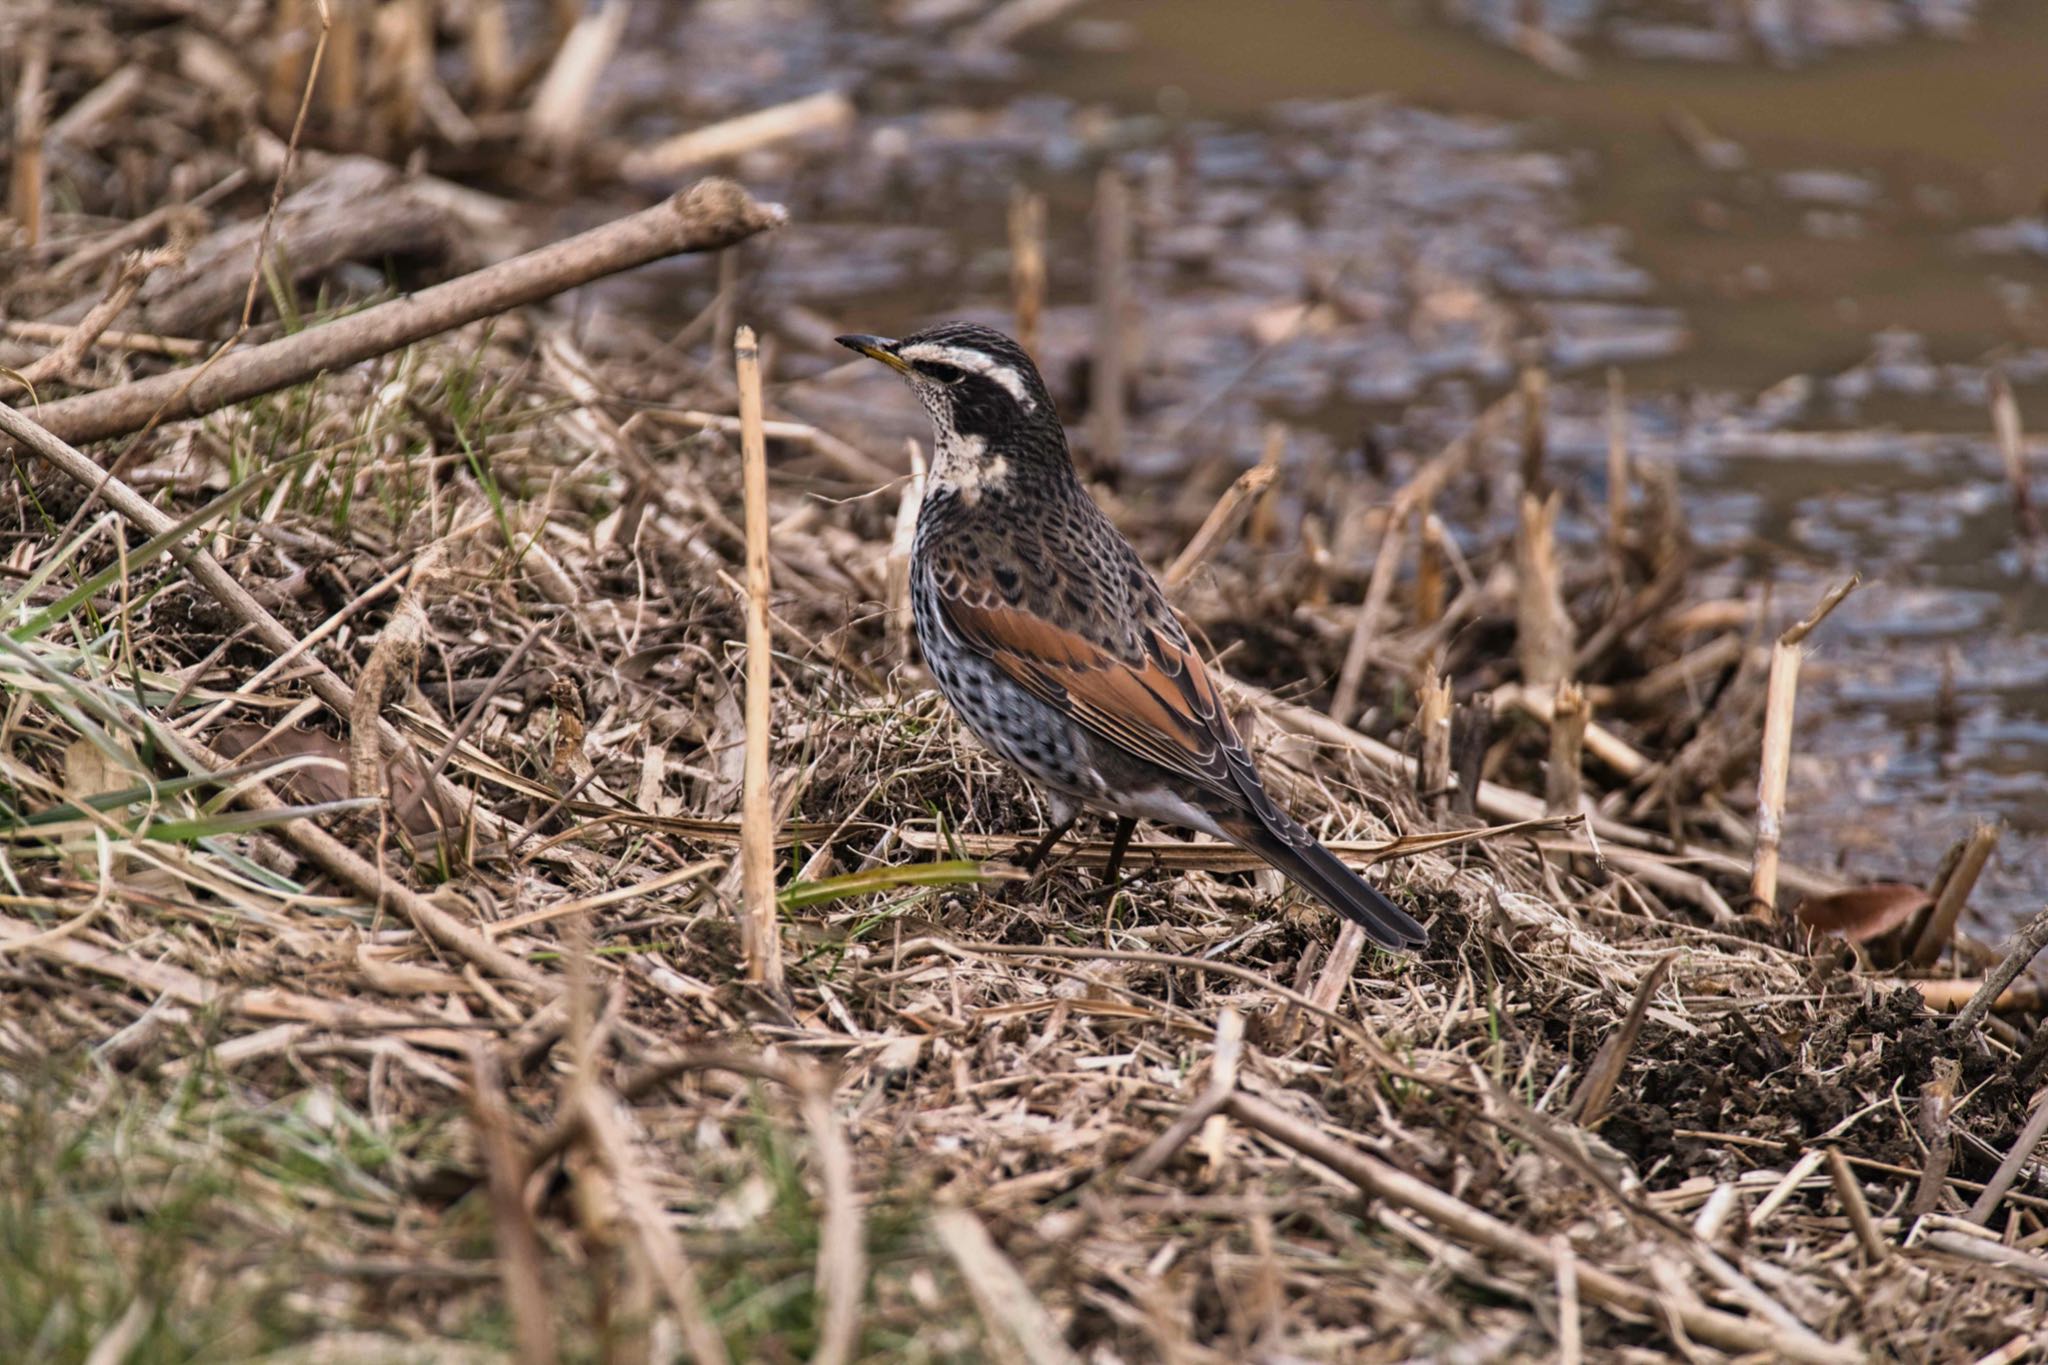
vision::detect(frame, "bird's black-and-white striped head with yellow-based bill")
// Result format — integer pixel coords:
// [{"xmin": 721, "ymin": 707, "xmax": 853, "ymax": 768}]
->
[{"xmin": 840, "ymin": 323, "xmax": 1065, "ymax": 452}]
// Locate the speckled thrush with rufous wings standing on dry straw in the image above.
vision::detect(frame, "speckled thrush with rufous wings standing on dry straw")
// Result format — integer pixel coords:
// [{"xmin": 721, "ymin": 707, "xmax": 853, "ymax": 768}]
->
[{"xmin": 838, "ymin": 321, "xmax": 1427, "ymax": 950}]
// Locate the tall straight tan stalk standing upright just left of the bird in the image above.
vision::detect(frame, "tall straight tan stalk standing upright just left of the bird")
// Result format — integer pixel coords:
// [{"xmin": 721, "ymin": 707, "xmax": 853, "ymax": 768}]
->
[{"xmin": 733, "ymin": 327, "xmax": 782, "ymax": 995}]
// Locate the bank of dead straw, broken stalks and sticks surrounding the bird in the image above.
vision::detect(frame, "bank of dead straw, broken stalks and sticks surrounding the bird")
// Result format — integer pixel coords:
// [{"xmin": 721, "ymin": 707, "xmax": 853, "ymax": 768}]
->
[{"xmin": 0, "ymin": 0, "xmax": 2048, "ymax": 1361}]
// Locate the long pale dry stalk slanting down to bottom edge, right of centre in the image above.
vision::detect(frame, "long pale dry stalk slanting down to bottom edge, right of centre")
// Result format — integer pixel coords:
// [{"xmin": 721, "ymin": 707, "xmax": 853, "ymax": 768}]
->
[{"xmin": 1229, "ymin": 1091, "xmax": 1864, "ymax": 1365}]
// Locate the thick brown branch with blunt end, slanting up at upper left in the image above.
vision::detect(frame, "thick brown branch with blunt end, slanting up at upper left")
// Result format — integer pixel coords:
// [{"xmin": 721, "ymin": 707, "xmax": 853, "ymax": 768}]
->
[{"xmin": 10, "ymin": 180, "xmax": 786, "ymax": 454}]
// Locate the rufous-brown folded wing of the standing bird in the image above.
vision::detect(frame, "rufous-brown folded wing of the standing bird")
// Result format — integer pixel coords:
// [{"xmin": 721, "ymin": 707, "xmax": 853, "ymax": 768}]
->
[{"xmin": 938, "ymin": 575, "xmax": 1266, "ymax": 806}]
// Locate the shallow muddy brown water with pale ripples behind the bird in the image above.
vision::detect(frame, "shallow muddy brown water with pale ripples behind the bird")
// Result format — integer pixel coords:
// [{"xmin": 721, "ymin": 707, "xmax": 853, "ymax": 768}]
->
[{"xmin": 623, "ymin": 0, "xmax": 2048, "ymax": 933}]
